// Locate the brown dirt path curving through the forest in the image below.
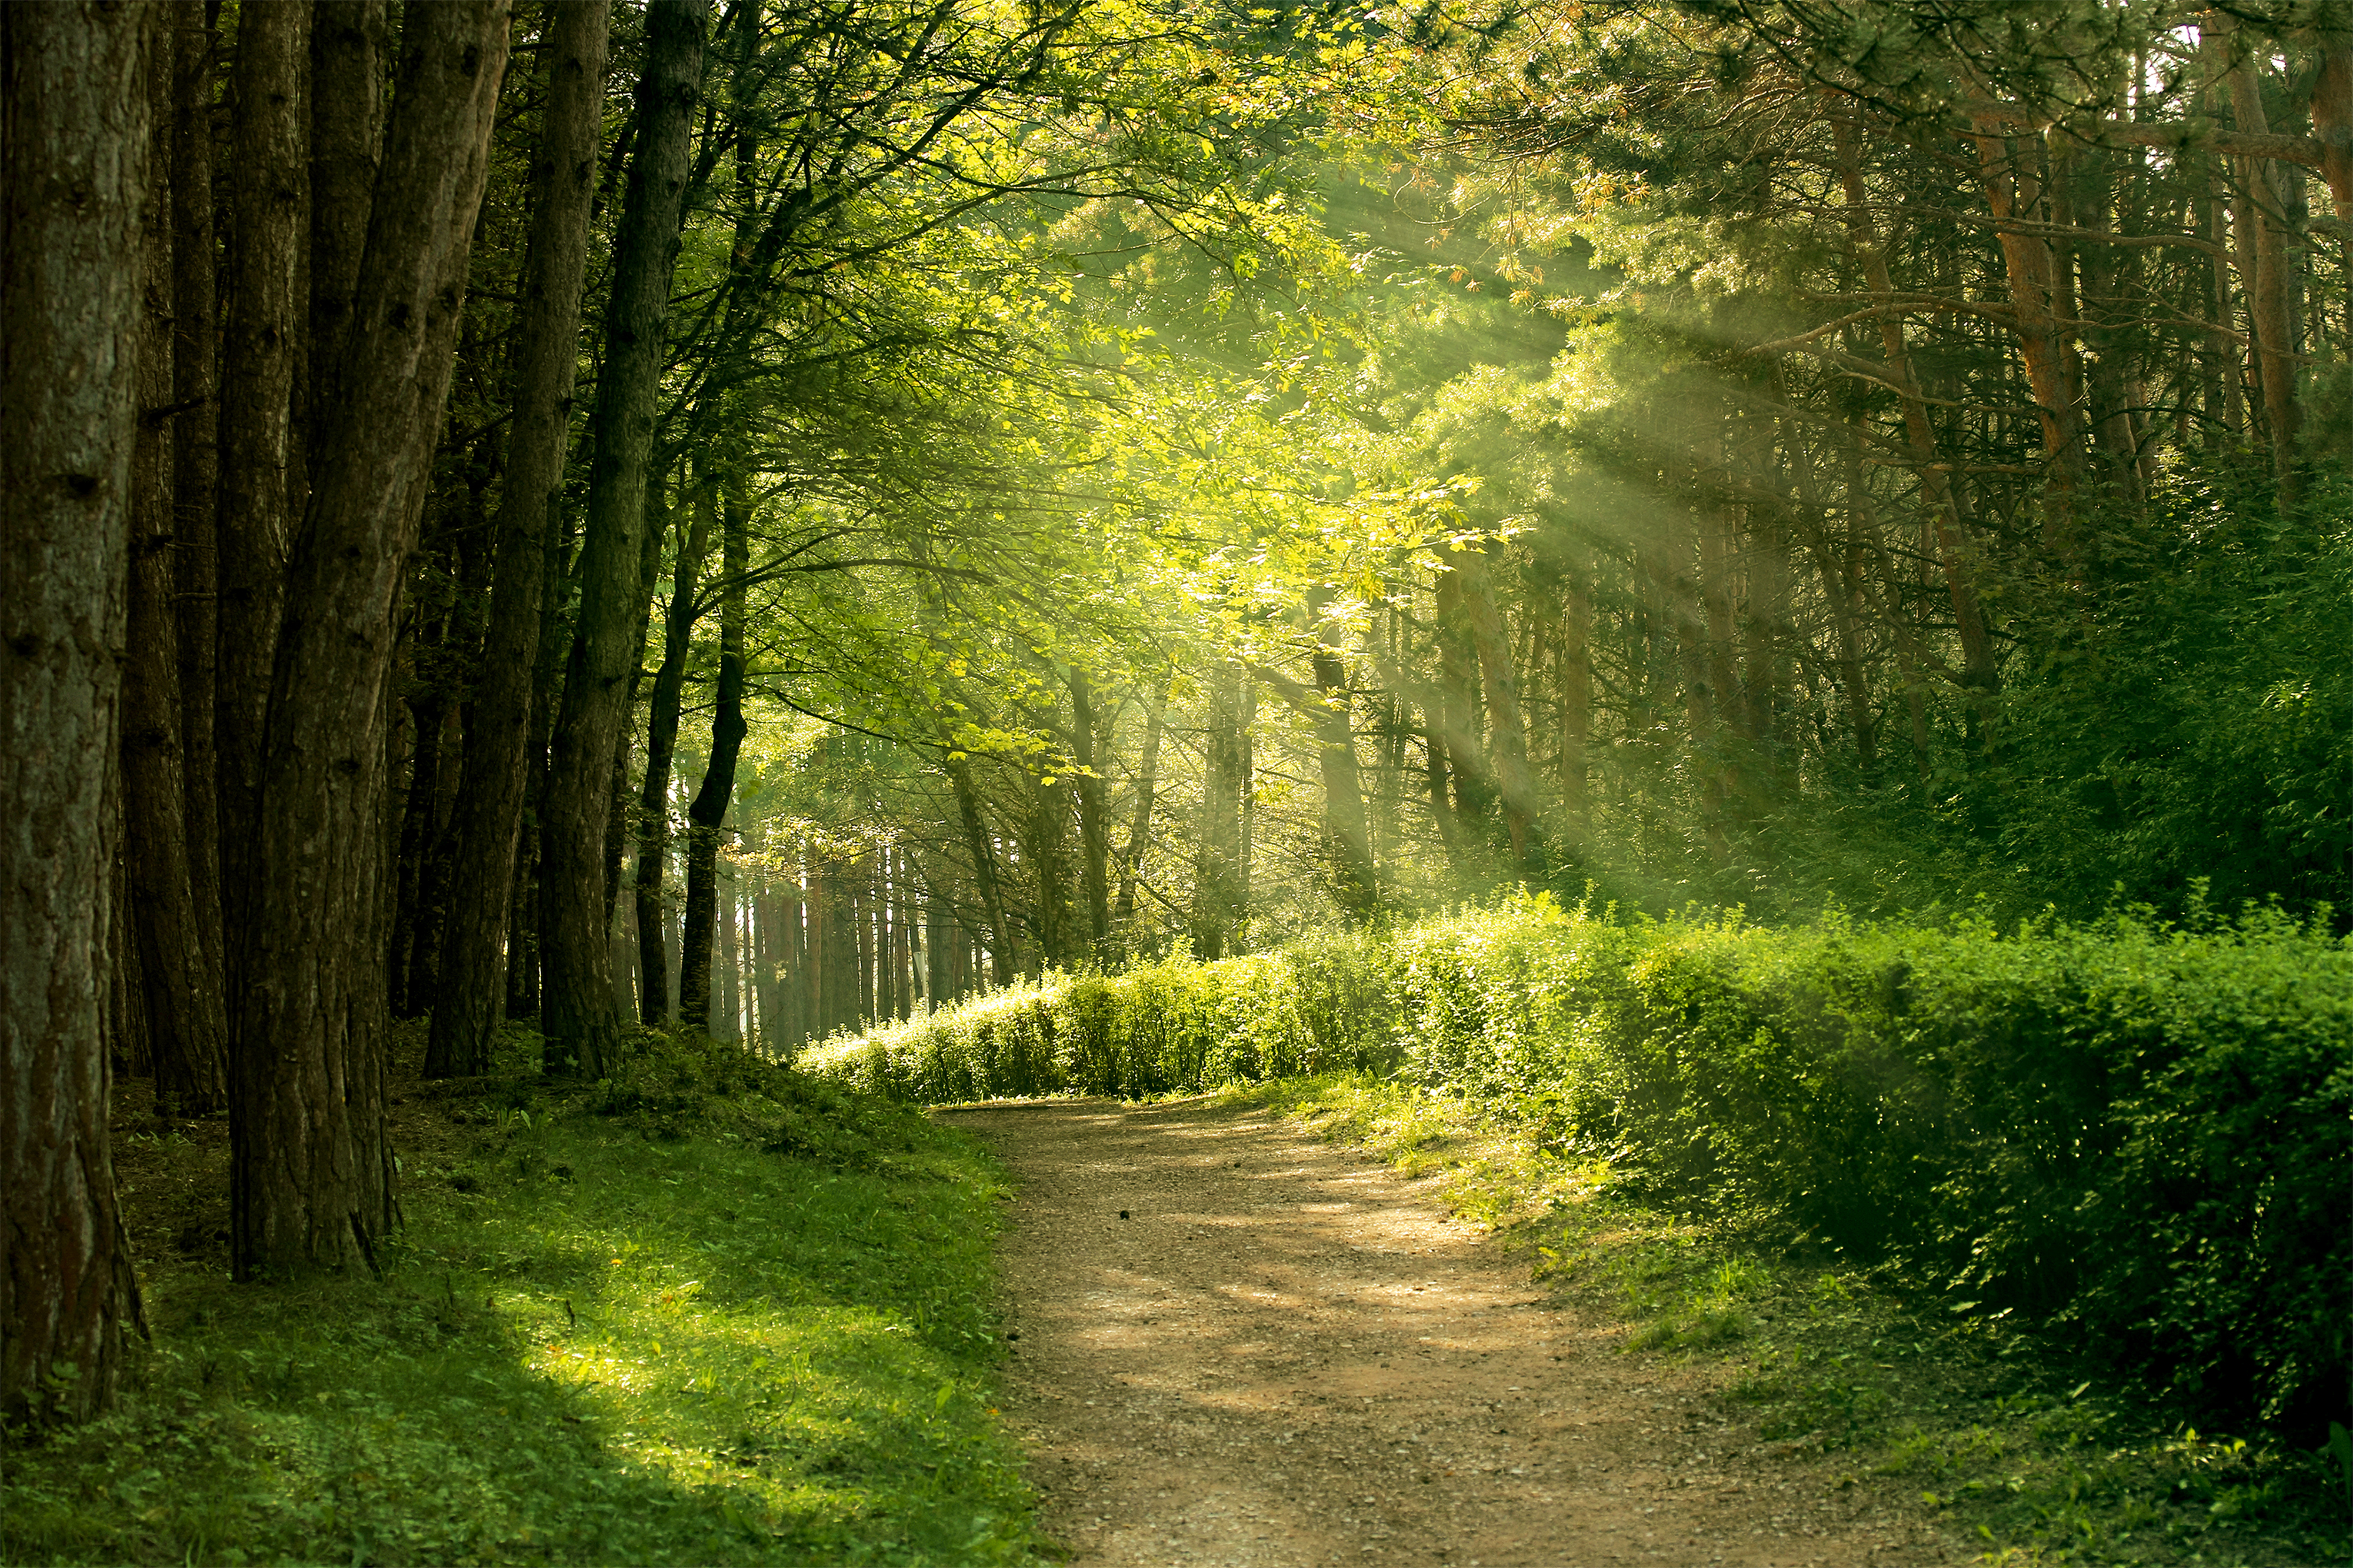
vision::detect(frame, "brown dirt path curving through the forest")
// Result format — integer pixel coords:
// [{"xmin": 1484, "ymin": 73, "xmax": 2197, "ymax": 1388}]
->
[{"xmin": 953, "ymin": 1099, "xmax": 1965, "ymax": 1568}]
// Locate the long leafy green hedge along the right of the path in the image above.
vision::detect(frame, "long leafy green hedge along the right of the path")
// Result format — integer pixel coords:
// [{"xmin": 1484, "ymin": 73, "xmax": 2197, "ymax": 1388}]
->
[{"xmin": 807, "ymin": 897, "xmax": 2353, "ymax": 1427}]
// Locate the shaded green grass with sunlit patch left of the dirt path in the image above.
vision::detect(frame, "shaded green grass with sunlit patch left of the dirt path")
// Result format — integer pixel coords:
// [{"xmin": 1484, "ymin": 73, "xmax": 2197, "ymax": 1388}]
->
[{"xmin": 0, "ymin": 1045, "xmax": 1033, "ymax": 1568}]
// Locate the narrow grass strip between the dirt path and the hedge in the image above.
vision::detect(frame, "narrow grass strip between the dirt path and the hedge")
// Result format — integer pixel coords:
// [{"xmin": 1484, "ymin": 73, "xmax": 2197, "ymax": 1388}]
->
[{"xmin": 1226, "ymin": 1076, "xmax": 2353, "ymax": 1568}]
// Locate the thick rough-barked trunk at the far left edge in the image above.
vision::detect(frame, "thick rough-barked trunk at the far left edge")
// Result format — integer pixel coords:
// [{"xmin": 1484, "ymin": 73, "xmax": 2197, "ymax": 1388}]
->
[{"xmin": 0, "ymin": 5, "xmax": 160, "ymax": 1422}]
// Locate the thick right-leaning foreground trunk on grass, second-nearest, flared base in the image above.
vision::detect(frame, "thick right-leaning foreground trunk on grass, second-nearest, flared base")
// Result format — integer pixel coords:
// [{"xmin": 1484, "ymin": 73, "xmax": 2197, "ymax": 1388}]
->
[{"xmin": 231, "ymin": 0, "xmax": 508, "ymax": 1279}]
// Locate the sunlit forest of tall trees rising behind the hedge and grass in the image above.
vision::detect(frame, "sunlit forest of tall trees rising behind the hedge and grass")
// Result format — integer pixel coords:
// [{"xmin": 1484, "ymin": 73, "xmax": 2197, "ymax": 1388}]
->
[{"xmin": 0, "ymin": 0, "xmax": 2353, "ymax": 1450}]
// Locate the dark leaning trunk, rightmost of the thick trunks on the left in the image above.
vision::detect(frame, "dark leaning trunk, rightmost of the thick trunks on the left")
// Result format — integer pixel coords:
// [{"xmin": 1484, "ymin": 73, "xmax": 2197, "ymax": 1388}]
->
[{"xmin": 541, "ymin": 0, "xmax": 711, "ymax": 1076}]
